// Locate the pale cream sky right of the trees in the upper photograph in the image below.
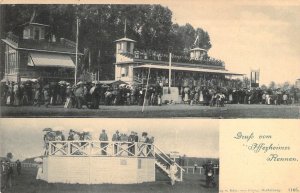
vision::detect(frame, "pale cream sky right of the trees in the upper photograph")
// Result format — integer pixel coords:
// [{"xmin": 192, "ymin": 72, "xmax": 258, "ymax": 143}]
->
[{"xmin": 162, "ymin": 0, "xmax": 300, "ymax": 85}]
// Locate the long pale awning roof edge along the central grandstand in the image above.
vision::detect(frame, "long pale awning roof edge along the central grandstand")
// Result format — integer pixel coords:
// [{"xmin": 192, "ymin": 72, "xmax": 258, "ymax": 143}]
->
[{"xmin": 134, "ymin": 64, "xmax": 244, "ymax": 76}]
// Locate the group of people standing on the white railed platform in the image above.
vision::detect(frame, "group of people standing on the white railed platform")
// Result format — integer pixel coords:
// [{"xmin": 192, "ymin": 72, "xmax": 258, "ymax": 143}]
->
[{"xmin": 44, "ymin": 128, "xmax": 154, "ymax": 156}]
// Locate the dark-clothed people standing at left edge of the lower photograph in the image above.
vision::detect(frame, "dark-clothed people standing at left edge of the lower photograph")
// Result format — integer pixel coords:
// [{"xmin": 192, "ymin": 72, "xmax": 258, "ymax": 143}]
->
[{"xmin": 1, "ymin": 160, "xmax": 21, "ymax": 192}]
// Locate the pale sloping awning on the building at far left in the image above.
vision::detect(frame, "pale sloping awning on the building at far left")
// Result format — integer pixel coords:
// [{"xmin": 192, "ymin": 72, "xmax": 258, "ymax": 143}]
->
[{"xmin": 28, "ymin": 52, "xmax": 75, "ymax": 68}]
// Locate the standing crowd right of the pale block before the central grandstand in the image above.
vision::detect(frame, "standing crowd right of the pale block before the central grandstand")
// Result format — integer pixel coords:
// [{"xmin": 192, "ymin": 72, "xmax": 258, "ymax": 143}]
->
[{"xmin": 177, "ymin": 87, "xmax": 298, "ymax": 107}]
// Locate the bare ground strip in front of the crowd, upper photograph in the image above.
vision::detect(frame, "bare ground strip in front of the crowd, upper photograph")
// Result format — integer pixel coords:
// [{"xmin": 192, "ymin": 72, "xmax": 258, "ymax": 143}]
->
[{"xmin": 1, "ymin": 104, "xmax": 300, "ymax": 119}]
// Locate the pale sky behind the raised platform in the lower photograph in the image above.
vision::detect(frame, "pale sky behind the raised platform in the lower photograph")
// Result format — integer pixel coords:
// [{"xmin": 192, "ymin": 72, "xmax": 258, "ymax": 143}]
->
[{"xmin": 0, "ymin": 118, "xmax": 219, "ymax": 160}]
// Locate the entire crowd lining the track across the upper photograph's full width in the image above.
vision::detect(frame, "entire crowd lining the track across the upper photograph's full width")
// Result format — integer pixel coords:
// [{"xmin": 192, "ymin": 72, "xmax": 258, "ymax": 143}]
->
[{"xmin": 1, "ymin": 77, "xmax": 299, "ymax": 109}]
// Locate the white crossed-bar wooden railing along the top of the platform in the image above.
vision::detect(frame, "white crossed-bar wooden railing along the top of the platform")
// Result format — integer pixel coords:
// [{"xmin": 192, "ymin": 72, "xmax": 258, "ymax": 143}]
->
[{"xmin": 44, "ymin": 141, "xmax": 155, "ymax": 157}]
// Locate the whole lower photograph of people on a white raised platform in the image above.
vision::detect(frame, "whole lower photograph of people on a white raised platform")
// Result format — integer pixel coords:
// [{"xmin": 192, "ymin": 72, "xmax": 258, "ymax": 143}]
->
[{"xmin": 0, "ymin": 118, "xmax": 220, "ymax": 193}]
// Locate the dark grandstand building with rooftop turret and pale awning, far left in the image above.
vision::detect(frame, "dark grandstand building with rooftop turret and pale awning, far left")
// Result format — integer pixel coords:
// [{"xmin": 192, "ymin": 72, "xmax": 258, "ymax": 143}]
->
[{"xmin": 2, "ymin": 22, "xmax": 82, "ymax": 82}]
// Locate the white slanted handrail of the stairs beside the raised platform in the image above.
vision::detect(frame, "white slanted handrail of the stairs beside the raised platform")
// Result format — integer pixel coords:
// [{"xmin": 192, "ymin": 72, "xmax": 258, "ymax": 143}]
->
[{"xmin": 153, "ymin": 145, "xmax": 185, "ymax": 181}]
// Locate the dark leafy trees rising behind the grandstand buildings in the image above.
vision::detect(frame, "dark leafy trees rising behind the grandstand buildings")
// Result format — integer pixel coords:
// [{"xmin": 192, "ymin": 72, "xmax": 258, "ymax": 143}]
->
[{"xmin": 1, "ymin": 4, "xmax": 211, "ymax": 79}]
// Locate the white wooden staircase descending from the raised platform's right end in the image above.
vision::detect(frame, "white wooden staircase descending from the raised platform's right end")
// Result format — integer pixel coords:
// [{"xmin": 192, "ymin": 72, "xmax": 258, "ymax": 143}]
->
[{"xmin": 153, "ymin": 145, "xmax": 184, "ymax": 182}]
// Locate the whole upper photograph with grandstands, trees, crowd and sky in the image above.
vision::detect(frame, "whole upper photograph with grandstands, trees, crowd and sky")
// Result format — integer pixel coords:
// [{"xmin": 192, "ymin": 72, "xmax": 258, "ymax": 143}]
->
[{"xmin": 0, "ymin": 1, "xmax": 300, "ymax": 119}]
